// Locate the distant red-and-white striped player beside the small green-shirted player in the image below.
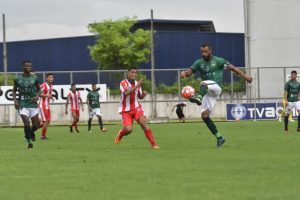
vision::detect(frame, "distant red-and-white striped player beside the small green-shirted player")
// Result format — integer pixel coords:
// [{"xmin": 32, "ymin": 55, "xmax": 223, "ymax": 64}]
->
[{"xmin": 65, "ymin": 83, "xmax": 84, "ymax": 133}]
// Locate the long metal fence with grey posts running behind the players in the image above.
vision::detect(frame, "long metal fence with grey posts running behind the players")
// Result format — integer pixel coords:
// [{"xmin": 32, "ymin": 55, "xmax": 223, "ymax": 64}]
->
[{"xmin": 0, "ymin": 67, "xmax": 299, "ymax": 125}]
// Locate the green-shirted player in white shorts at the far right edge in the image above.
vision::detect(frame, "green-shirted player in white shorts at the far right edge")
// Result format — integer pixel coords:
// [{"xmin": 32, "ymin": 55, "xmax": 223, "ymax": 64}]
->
[{"xmin": 284, "ymin": 71, "xmax": 300, "ymax": 133}]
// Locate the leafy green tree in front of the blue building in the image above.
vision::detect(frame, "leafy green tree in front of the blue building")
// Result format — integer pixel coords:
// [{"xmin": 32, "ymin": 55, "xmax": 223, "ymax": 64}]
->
[{"xmin": 88, "ymin": 17, "xmax": 151, "ymax": 69}]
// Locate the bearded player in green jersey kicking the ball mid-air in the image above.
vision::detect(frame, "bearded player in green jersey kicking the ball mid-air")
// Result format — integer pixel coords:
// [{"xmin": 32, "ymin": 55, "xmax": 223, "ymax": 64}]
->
[{"xmin": 181, "ymin": 43, "xmax": 252, "ymax": 147}]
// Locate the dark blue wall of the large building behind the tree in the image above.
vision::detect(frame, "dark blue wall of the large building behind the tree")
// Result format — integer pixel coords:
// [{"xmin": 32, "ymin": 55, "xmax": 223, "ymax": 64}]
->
[{"xmin": 0, "ymin": 31, "xmax": 245, "ymax": 71}]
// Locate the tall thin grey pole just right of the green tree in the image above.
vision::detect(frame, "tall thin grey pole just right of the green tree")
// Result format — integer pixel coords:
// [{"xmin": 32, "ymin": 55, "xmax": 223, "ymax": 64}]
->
[{"xmin": 151, "ymin": 9, "xmax": 156, "ymax": 118}]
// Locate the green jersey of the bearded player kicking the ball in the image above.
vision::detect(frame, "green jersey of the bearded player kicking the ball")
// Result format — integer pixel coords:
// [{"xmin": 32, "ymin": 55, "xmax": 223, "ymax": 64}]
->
[{"xmin": 191, "ymin": 56, "xmax": 230, "ymax": 85}]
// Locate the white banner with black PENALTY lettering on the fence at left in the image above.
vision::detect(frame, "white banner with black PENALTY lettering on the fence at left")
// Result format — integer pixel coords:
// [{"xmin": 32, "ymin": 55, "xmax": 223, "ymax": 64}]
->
[{"xmin": 0, "ymin": 84, "xmax": 107, "ymax": 104}]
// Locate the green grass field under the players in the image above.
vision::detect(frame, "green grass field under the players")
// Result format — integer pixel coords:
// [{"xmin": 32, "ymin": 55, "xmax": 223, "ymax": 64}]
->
[{"xmin": 0, "ymin": 121, "xmax": 300, "ymax": 200}]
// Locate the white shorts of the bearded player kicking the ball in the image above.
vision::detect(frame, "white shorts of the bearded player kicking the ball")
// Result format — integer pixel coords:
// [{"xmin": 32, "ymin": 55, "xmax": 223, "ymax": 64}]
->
[{"xmin": 201, "ymin": 80, "xmax": 222, "ymax": 112}]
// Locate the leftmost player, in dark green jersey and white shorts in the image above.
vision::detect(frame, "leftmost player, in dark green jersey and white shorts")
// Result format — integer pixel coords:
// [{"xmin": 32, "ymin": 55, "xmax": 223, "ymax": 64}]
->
[{"xmin": 13, "ymin": 60, "xmax": 40, "ymax": 149}]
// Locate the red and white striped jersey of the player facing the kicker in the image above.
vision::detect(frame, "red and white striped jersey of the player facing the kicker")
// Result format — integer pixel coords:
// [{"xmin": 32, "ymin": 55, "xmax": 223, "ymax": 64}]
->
[{"xmin": 119, "ymin": 79, "xmax": 142, "ymax": 113}]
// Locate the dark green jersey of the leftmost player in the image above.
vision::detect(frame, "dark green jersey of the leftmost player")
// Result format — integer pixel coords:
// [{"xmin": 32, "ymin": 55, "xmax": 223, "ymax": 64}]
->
[{"xmin": 14, "ymin": 74, "xmax": 38, "ymax": 108}]
